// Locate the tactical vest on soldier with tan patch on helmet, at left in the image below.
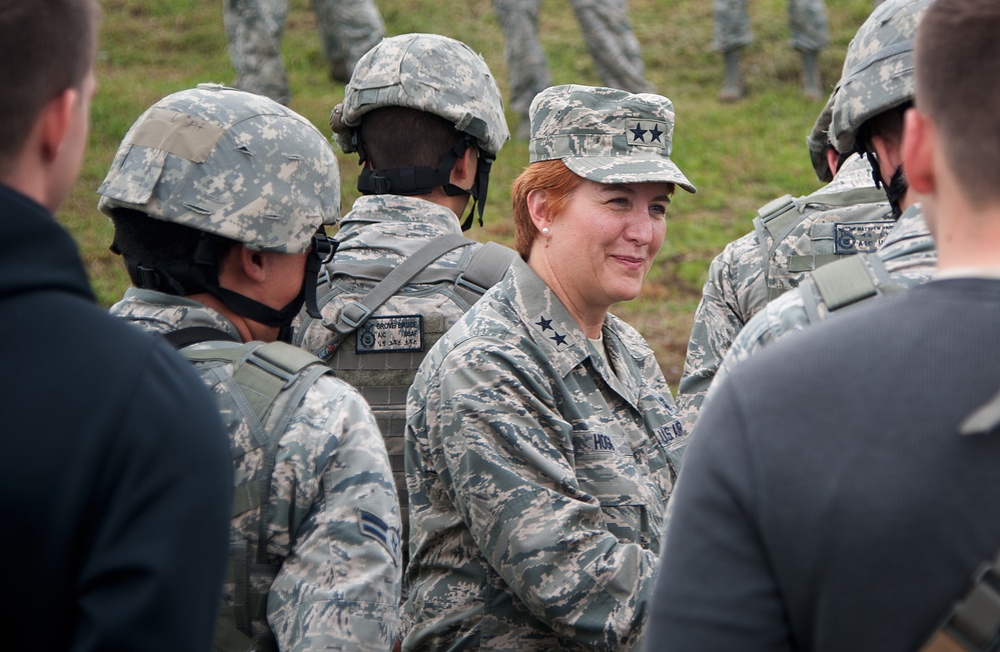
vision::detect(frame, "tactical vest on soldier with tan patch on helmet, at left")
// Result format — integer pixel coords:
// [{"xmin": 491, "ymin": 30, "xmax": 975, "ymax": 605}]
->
[{"xmin": 165, "ymin": 327, "xmax": 330, "ymax": 652}]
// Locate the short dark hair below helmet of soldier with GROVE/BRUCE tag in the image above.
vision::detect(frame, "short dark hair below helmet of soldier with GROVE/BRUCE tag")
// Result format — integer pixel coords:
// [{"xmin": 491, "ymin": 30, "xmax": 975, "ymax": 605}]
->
[{"xmin": 358, "ymin": 106, "xmax": 462, "ymax": 170}]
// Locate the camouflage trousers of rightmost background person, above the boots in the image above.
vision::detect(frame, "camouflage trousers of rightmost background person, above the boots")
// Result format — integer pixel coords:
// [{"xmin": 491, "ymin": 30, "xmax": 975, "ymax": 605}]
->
[{"xmin": 712, "ymin": 0, "xmax": 827, "ymax": 52}]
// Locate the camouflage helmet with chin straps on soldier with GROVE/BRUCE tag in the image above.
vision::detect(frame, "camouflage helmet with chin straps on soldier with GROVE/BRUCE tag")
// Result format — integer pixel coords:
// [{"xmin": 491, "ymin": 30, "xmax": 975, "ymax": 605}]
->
[{"xmin": 330, "ymin": 34, "xmax": 510, "ymax": 230}]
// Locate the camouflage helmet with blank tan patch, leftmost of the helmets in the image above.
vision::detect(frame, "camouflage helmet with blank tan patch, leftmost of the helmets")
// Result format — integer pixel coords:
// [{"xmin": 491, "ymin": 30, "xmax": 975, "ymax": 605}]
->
[{"xmin": 97, "ymin": 84, "xmax": 340, "ymax": 253}]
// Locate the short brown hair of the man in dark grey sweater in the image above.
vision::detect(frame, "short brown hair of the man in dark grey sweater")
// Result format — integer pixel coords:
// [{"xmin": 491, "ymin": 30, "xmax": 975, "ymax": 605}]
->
[{"xmin": 915, "ymin": 0, "xmax": 1000, "ymax": 205}]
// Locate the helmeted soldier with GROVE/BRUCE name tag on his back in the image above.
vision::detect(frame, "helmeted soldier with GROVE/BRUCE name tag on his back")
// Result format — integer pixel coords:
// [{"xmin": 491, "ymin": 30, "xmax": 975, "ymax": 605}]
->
[{"xmin": 295, "ymin": 34, "xmax": 514, "ymax": 580}]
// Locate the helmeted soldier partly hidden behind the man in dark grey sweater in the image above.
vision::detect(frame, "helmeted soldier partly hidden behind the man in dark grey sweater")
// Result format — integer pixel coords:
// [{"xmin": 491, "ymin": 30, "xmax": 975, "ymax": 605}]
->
[{"xmin": 713, "ymin": 0, "xmax": 937, "ymax": 382}]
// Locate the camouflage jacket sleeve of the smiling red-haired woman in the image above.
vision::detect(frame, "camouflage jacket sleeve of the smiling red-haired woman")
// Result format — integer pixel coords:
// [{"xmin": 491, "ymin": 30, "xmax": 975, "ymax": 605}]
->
[{"xmin": 424, "ymin": 340, "xmax": 656, "ymax": 649}]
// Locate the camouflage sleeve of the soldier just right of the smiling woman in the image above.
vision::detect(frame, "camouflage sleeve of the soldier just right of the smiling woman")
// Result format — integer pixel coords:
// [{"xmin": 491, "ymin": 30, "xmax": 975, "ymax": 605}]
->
[{"xmin": 677, "ymin": 233, "xmax": 767, "ymax": 432}]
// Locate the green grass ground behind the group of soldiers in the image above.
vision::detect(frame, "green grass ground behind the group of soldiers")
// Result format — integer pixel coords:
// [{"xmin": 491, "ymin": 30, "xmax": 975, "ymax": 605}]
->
[{"xmin": 59, "ymin": 0, "xmax": 871, "ymax": 390}]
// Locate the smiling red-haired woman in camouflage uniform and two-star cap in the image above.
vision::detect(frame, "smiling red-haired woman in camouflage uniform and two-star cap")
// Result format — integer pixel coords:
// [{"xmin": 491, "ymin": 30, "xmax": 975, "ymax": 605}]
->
[{"xmin": 403, "ymin": 85, "xmax": 695, "ymax": 650}]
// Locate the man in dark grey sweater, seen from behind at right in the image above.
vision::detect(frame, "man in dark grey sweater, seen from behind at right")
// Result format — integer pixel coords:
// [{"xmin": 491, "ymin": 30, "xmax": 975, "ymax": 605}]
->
[{"xmin": 651, "ymin": 0, "xmax": 1000, "ymax": 652}]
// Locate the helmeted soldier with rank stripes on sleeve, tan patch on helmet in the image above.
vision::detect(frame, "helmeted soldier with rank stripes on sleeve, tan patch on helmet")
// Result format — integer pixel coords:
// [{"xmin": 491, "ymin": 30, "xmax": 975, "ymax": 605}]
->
[{"xmin": 98, "ymin": 85, "xmax": 400, "ymax": 650}]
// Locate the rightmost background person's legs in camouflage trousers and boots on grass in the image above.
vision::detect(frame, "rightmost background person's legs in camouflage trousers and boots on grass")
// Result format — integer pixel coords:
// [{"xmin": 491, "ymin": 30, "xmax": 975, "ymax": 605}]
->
[{"xmin": 713, "ymin": 0, "xmax": 827, "ymax": 102}]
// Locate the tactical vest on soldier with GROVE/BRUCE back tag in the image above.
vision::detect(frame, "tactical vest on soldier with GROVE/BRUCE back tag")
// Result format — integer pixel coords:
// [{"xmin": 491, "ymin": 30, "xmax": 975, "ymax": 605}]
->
[{"xmin": 299, "ymin": 234, "xmax": 517, "ymax": 573}]
